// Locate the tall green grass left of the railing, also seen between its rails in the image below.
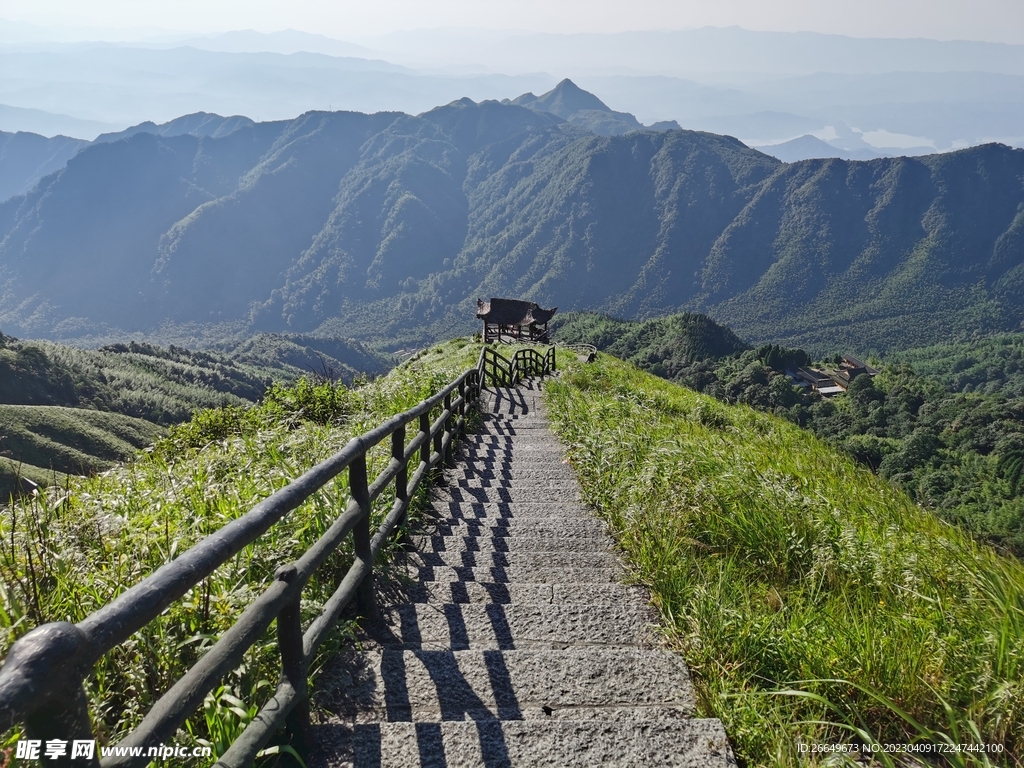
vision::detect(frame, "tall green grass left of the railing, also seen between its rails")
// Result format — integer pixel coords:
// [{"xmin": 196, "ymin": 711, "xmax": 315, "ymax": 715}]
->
[{"xmin": 0, "ymin": 341, "xmax": 479, "ymax": 765}]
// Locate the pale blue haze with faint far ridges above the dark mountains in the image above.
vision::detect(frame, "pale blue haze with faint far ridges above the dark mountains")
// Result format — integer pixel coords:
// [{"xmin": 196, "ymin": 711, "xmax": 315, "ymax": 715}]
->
[{"xmin": 0, "ymin": 22, "xmax": 1024, "ymax": 155}]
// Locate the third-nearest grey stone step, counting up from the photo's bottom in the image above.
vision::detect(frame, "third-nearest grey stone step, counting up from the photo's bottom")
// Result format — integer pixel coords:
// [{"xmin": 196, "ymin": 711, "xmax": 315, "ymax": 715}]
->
[{"xmin": 371, "ymin": 600, "xmax": 657, "ymax": 650}]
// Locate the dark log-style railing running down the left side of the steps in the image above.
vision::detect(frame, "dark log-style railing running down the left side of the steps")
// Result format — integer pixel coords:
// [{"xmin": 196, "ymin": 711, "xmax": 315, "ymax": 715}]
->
[{"xmin": 0, "ymin": 345, "xmax": 555, "ymax": 768}]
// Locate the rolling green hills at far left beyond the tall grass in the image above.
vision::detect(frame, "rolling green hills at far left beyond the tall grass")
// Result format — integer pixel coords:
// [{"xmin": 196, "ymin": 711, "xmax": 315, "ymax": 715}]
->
[{"xmin": 0, "ymin": 334, "xmax": 388, "ymax": 503}]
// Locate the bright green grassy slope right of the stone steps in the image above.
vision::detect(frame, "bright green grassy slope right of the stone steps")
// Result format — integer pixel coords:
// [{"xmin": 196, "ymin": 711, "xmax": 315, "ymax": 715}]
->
[{"xmin": 547, "ymin": 355, "xmax": 1024, "ymax": 766}]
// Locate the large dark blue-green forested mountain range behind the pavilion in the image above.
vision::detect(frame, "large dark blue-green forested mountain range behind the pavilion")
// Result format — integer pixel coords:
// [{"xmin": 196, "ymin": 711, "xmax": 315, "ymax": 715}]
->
[{"xmin": 0, "ymin": 82, "xmax": 1024, "ymax": 350}]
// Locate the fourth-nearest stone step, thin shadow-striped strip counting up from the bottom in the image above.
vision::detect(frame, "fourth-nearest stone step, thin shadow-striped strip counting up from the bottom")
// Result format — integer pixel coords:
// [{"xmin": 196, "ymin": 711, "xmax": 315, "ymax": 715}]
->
[{"xmin": 383, "ymin": 582, "xmax": 647, "ymax": 605}]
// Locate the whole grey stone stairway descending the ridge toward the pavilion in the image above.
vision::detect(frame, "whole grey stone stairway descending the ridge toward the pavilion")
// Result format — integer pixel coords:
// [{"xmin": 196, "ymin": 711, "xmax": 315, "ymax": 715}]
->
[{"xmin": 310, "ymin": 381, "xmax": 735, "ymax": 768}]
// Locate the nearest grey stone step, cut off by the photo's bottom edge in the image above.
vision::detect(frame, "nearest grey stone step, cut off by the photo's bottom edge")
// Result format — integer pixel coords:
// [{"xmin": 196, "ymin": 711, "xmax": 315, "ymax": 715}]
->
[{"xmin": 310, "ymin": 719, "xmax": 736, "ymax": 768}]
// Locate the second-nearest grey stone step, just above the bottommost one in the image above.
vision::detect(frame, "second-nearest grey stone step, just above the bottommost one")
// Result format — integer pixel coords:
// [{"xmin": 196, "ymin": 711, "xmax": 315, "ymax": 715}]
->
[{"xmin": 317, "ymin": 647, "xmax": 695, "ymax": 722}]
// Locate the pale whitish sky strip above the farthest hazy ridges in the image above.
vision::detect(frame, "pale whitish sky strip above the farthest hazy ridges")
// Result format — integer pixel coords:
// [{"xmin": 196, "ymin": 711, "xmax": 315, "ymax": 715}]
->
[{"xmin": 6, "ymin": 0, "xmax": 1024, "ymax": 43}]
